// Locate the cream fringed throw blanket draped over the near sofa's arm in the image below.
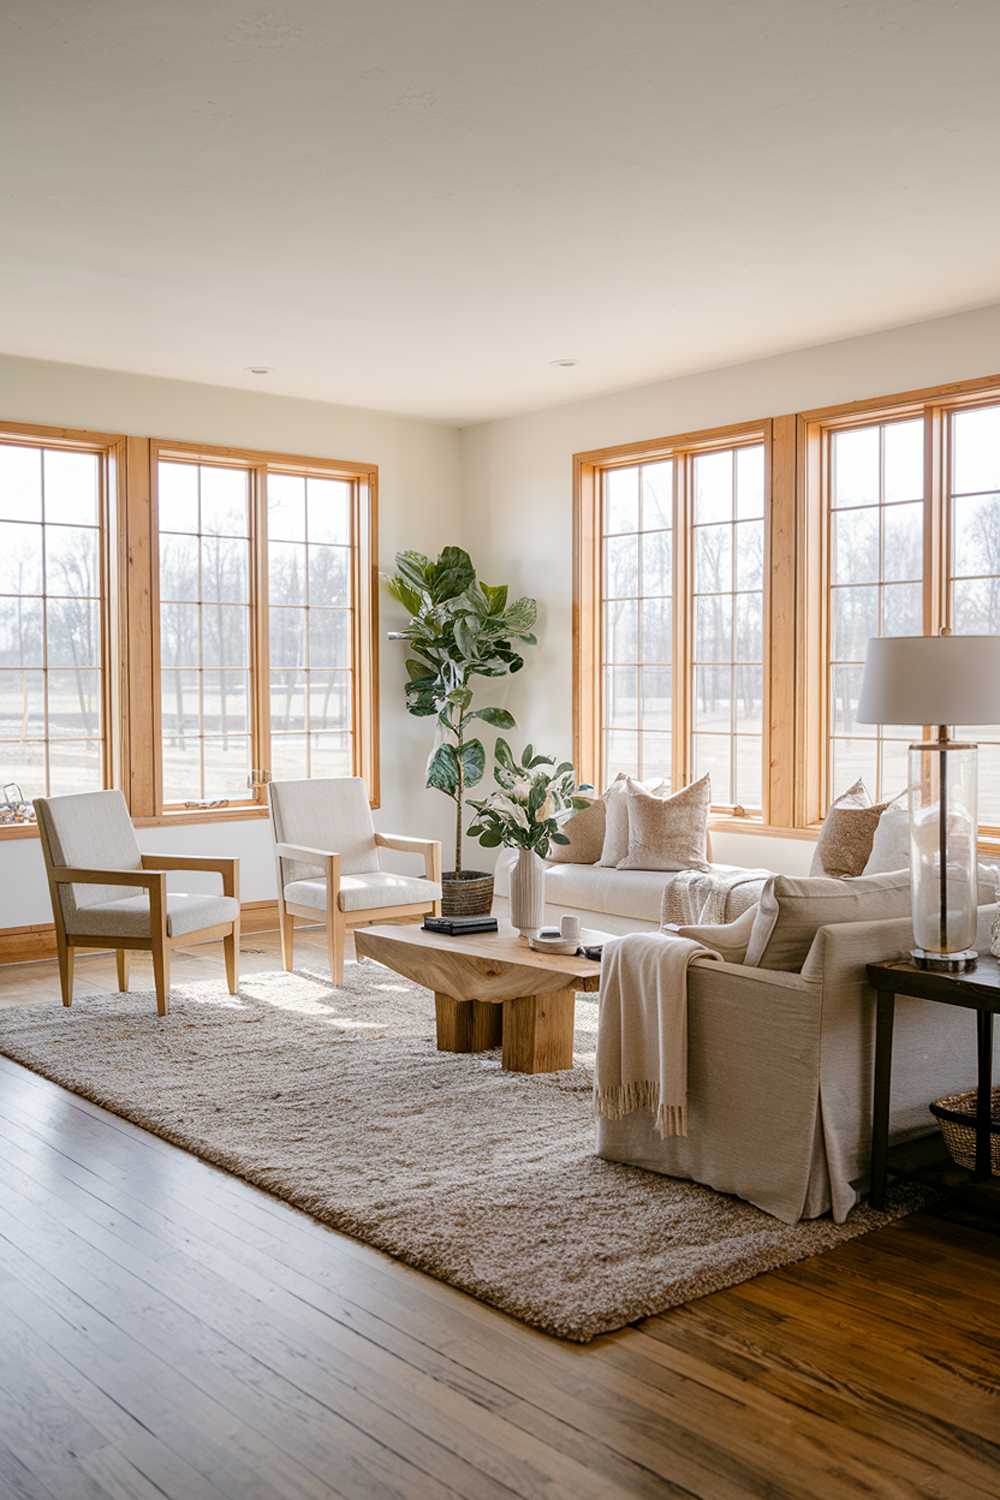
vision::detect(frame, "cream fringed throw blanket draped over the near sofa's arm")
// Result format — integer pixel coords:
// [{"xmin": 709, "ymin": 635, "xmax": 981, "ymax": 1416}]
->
[{"xmin": 594, "ymin": 933, "xmax": 720, "ymax": 1137}]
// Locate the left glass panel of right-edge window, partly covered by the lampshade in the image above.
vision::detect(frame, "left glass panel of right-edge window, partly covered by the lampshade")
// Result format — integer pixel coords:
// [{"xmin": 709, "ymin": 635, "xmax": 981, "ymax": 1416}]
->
[{"xmin": 826, "ymin": 417, "xmax": 925, "ymax": 806}]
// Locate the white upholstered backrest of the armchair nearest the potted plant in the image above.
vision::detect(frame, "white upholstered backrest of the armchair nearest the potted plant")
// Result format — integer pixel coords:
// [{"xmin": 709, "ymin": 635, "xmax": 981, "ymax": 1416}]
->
[{"xmin": 268, "ymin": 776, "xmax": 381, "ymax": 882}]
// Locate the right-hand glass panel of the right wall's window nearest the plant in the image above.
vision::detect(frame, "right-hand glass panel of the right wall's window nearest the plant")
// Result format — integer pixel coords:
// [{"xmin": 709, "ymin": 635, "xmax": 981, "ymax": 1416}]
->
[{"xmin": 690, "ymin": 443, "xmax": 765, "ymax": 812}]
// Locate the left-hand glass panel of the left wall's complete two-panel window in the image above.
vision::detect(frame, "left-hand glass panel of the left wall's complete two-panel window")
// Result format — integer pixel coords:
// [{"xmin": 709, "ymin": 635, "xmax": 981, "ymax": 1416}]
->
[{"xmin": 157, "ymin": 461, "xmax": 253, "ymax": 806}]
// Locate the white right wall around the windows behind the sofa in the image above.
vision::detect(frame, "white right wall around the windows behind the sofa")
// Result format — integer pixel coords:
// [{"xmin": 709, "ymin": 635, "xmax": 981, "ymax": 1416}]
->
[{"xmin": 462, "ymin": 306, "xmax": 1000, "ymax": 873}]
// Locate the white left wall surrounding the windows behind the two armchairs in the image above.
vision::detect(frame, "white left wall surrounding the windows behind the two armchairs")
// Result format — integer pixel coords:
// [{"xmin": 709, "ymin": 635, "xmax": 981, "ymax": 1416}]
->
[{"xmin": 0, "ymin": 356, "xmax": 468, "ymax": 929}]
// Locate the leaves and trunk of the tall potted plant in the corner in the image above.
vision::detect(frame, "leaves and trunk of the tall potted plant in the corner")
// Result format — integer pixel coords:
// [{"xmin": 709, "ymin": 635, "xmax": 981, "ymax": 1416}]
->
[{"xmin": 388, "ymin": 548, "xmax": 537, "ymax": 879}]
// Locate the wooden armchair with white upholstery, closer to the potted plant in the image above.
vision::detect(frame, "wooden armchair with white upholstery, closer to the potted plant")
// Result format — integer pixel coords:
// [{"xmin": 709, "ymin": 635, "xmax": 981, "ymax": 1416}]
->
[{"xmin": 268, "ymin": 776, "xmax": 441, "ymax": 984}]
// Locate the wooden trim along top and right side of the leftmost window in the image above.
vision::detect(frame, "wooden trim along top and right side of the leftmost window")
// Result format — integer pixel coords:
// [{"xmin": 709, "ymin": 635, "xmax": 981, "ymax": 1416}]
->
[{"xmin": 0, "ymin": 422, "xmax": 126, "ymax": 842}]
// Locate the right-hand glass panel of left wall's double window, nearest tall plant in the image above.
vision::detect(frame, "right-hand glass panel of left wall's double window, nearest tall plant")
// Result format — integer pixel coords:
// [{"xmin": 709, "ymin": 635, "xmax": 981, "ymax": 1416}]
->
[{"xmin": 267, "ymin": 473, "xmax": 355, "ymax": 779}]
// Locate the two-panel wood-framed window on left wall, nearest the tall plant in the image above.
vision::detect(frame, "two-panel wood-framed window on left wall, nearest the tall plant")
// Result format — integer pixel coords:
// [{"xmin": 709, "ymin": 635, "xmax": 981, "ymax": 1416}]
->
[{"xmin": 150, "ymin": 443, "xmax": 378, "ymax": 813}]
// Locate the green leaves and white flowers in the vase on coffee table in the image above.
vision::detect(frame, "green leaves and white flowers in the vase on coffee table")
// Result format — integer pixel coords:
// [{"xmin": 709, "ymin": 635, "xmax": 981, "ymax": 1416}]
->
[{"xmin": 469, "ymin": 740, "xmax": 592, "ymax": 860}]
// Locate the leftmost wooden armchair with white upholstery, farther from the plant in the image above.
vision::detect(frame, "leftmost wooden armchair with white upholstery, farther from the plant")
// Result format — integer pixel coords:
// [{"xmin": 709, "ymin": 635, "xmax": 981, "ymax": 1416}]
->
[{"xmin": 34, "ymin": 792, "xmax": 240, "ymax": 1016}]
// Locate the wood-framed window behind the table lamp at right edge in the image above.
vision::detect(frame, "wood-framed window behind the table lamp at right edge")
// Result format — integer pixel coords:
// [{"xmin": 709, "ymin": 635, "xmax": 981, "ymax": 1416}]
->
[{"xmin": 799, "ymin": 372, "xmax": 1000, "ymax": 839}]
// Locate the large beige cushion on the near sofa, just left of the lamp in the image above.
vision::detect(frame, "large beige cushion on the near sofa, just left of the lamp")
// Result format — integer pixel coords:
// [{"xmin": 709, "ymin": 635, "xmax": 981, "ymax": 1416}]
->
[{"xmin": 745, "ymin": 870, "xmax": 910, "ymax": 974}]
